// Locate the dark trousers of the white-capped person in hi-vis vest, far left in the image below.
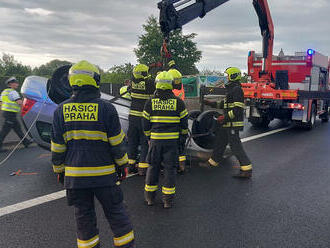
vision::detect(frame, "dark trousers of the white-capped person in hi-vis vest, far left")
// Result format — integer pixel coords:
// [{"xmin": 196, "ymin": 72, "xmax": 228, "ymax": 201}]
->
[{"xmin": 0, "ymin": 111, "xmax": 30, "ymax": 148}]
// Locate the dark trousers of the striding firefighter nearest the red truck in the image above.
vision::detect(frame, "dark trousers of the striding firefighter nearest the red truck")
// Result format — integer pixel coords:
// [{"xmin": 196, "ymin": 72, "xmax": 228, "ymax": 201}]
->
[{"xmin": 209, "ymin": 127, "xmax": 252, "ymax": 171}]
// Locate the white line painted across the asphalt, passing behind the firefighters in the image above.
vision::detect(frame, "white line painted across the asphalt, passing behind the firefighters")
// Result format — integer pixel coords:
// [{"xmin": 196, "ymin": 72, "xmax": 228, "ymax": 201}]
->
[{"xmin": 0, "ymin": 127, "xmax": 290, "ymax": 217}]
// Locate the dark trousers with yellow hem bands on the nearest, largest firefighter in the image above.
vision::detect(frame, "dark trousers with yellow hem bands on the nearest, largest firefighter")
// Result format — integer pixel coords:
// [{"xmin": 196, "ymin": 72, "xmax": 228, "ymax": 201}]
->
[{"xmin": 67, "ymin": 185, "xmax": 134, "ymax": 248}]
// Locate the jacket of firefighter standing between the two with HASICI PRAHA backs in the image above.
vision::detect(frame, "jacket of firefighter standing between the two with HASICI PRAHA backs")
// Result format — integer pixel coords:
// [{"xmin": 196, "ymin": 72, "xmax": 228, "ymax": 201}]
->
[{"xmin": 129, "ymin": 76, "xmax": 155, "ymax": 118}]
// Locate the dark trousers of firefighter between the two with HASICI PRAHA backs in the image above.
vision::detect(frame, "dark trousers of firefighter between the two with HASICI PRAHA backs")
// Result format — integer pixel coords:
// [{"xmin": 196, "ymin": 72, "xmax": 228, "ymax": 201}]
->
[{"xmin": 127, "ymin": 116, "xmax": 149, "ymax": 170}]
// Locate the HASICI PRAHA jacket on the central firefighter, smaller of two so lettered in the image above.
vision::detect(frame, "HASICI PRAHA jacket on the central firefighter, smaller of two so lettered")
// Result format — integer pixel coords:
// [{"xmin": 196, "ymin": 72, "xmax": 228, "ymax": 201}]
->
[{"xmin": 143, "ymin": 90, "xmax": 188, "ymax": 142}]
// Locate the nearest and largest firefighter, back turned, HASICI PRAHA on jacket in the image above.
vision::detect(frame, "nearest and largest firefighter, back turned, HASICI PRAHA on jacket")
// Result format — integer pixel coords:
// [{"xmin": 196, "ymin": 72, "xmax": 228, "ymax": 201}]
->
[{"xmin": 51, "ymin": 60, "xmax": 134, "ymax": 248}]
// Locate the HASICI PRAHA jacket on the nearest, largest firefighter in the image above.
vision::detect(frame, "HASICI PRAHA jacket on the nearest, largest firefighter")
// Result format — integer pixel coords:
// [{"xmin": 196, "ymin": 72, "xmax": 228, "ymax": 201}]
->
[{"xmin": 51, "ymin": 89, "xmax": 128, "ymax": 189}]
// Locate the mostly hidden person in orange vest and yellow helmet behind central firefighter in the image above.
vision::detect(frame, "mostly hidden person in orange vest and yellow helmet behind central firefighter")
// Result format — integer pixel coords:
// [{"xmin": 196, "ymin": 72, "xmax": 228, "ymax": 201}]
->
[{"xmin": 168, "ymin": 69, "xmax": 186, "ymax": 174}]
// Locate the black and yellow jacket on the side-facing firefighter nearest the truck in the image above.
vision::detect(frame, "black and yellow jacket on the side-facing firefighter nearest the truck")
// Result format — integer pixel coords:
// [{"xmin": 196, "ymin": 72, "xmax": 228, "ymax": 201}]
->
[{"xmin": 211, "ymin": 82, "xmax": 245, "ymax": 131}]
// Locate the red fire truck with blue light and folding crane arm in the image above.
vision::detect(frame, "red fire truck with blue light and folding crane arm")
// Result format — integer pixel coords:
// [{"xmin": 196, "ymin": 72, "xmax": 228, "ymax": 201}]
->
[{"xmin": 158, "ymin": 0, "xmax": 330, "ymax": 132}]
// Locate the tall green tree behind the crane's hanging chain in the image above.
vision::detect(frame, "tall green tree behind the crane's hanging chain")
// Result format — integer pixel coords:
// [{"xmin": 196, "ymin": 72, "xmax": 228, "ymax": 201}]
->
[{"xmin": 134, "ymin": 16, "xmax": 202, "ymax": 75}]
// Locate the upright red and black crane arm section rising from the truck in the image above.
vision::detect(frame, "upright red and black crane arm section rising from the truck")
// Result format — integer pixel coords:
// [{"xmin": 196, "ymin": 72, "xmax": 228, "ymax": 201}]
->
[{"xmin": 253, "ymin": 0, "xmax": 274, "ymax": 77}]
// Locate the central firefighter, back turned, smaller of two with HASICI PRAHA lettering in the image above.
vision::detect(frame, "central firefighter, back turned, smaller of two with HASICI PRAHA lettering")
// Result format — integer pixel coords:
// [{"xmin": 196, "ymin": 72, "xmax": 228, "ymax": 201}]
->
[{"xmin": 143, "ymin": 71, "xmax": 188, "ymax": 208}]
